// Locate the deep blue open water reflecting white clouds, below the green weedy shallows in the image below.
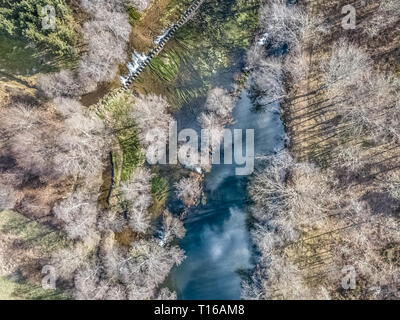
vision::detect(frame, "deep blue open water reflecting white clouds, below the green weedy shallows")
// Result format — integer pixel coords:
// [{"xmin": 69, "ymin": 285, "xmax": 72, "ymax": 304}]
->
[{"xmin": 169, "ymin": 90, "xmax": 284, "ymax": 300}]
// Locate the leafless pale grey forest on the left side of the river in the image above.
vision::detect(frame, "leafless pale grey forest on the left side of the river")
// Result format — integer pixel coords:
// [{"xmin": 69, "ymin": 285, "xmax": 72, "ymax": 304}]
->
[{"xmin": 0, "ymin": 0, "xmax": 187, "ymax": 299}]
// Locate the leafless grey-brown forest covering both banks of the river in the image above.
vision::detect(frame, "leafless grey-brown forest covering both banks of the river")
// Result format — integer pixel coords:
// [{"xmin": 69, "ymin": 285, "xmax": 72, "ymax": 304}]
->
[{"xmin": 0, "ymin": 0, "xmax": 400, "ymax": 300}]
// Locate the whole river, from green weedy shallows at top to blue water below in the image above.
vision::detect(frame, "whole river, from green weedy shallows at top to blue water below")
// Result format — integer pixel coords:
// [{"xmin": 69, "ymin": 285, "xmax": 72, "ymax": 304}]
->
[{"xmin": 139, "ymin": 0, "xmax": 284, "ymax": 300}]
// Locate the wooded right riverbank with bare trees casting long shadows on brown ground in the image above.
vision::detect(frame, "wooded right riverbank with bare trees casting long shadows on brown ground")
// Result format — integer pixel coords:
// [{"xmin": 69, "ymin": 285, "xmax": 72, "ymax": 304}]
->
[{"xmin": 243, "ymin": 1, "xmax": 400, "ymax": 299}]
